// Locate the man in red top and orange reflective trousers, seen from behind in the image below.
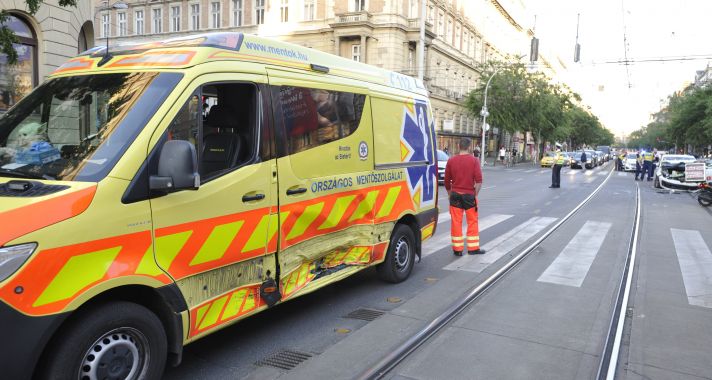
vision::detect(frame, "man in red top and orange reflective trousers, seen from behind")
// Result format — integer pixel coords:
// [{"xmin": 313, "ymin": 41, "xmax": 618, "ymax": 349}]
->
[{"xmin": 445, "ymin": 138, "xmax": 485, "ymax": 256}]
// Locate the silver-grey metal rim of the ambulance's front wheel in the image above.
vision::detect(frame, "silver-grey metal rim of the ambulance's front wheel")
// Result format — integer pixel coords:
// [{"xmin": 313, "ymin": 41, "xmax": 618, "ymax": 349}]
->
[{"xmin": 79, "ymin": 327, "xmax": 149, "ymax": 380}]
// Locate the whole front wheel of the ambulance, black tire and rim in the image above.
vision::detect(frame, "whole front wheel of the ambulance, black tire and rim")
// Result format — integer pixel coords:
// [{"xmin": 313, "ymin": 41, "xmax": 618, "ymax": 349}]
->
[{"xmin": 38, "ymin": 301, "xmax": 167, "ymax": 380}]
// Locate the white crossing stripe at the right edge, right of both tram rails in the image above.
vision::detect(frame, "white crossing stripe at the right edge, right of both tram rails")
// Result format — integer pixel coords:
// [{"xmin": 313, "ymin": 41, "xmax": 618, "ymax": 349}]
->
[{"xmin": 670, "ymin": 228, "xmax": 712, "ymax": 308}]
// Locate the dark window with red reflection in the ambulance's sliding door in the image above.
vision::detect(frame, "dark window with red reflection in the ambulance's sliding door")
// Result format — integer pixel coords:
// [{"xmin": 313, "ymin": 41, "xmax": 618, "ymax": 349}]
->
[{"xmin": 278, "ymin": 86, "xmax": 366, "ymax": 154}]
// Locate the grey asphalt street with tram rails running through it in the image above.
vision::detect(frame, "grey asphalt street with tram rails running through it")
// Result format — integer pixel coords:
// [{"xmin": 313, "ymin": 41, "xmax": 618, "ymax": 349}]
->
[{"xmin": 165, "ymin": 163, "xmax": 712, "ymax": 379}]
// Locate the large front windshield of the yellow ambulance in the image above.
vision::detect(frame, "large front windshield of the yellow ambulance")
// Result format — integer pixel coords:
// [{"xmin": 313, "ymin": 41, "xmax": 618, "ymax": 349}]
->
[{"xmin": 0, "ymin": 72, "xmax": 181, "ymax": 182}]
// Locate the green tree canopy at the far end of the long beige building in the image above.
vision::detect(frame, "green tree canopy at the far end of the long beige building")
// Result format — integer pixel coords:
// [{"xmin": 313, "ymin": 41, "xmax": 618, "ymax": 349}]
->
[{"xmin": 465, "ymin": 62, "xmax": 613, "ymax": 146}]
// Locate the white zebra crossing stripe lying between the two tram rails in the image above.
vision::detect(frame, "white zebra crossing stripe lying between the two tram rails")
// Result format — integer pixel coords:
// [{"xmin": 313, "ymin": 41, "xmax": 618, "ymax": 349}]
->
[{"xmin": 537, "ymin": 220, "xmax": 611, "ymax": 288}]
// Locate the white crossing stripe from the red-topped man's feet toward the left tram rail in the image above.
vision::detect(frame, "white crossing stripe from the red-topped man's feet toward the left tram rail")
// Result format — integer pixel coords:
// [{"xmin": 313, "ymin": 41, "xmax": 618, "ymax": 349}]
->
[{"xmin": 443, "ymin": 216, "xmax": 557, "ymax": 273}]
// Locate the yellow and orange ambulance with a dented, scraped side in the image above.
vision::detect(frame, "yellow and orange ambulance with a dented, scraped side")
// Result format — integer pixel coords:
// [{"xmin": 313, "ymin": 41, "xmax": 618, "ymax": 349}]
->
[{"xmin": 0, "ymin": 33, "xmax": 437, "ymax": 379}]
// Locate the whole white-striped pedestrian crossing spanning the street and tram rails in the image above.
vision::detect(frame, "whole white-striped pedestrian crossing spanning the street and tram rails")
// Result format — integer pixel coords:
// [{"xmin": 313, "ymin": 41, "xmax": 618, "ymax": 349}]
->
[{"xmin": 422, "ymin": 213, "xmax": 712, "ymax": 308}]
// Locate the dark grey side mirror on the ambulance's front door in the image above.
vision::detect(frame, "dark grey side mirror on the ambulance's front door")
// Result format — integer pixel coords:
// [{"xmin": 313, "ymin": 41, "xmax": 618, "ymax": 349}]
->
[{"xmin": 149, "ymin": 140, "xmax": 200, "ymax": 193}]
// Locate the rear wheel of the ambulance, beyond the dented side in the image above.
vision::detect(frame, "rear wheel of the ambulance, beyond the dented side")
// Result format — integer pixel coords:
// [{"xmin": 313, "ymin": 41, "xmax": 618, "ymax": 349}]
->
[{"xmin": 376, "ymin": 224, "xmax": 415, "ymax": 284}]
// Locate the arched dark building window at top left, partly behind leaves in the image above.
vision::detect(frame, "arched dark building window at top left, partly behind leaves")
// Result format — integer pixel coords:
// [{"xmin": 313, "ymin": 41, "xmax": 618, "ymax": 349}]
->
[{"xmin": 0, "ymin": 14, "xmax": 37, "ymax": 111}]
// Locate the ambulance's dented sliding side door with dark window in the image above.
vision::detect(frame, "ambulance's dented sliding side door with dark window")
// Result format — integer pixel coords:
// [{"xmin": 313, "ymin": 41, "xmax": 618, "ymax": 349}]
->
[{"xmin": 268, "ymin": 69, "xmax": 381, "ymax": 299}]
